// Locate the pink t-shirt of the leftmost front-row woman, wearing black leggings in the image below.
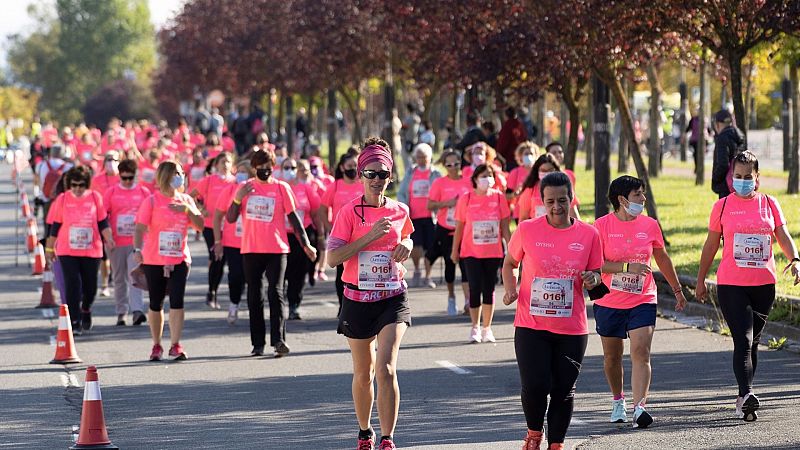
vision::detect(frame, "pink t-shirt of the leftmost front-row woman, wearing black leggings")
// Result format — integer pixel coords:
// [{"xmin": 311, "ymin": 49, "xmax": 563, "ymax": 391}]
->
[{"xmin": 48, "ymin": 190, "xmax": 106, "ymax": 258}]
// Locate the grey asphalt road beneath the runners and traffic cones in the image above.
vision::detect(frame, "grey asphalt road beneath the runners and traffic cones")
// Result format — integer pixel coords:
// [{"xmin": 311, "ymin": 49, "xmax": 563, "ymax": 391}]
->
[{"xmin": 0, "ymin": 166, "xmax": 800, "ymax": 449}]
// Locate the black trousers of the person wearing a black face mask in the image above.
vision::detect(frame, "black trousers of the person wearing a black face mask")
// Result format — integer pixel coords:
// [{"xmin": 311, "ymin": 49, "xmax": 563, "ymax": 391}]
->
[{"xmin": 242, "ymin": 253, "xmax": 286, "ymax": 347}]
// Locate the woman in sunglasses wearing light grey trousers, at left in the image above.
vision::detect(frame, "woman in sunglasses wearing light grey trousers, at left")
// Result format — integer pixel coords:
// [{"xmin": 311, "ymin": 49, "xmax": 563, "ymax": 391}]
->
[{"xmin": 103, "ymin": 159, "xmax": 151, "ymax": 326}]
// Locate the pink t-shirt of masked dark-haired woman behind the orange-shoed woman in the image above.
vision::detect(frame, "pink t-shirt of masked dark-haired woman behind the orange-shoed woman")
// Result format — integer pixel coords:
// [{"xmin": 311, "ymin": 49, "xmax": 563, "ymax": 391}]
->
[{"xmin": 456, "ymin": 189, "xmax": 511, "ymax": 258}]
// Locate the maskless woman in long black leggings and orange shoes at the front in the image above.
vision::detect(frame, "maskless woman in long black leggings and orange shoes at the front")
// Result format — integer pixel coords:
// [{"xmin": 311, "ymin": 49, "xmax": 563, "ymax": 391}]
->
[{"xmin": 503, "ymin": 172, "xmax": 607, "ymax": 450}]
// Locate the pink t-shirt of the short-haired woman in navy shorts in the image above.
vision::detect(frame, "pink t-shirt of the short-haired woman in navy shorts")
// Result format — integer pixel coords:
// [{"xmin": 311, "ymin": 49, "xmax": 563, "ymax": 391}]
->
[{"xmin": 594, "ymin": 213, "xmax": 664, "ymax": 309}]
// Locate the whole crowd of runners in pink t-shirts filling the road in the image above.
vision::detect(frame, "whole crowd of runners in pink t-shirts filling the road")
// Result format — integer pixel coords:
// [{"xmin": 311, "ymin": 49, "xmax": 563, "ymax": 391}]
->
[{"xmin": 25, "ymin": 115, "xmax": 800, "ymax": 450}]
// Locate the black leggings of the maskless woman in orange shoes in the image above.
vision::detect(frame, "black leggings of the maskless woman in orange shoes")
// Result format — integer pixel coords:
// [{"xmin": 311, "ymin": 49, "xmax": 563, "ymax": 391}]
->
[{"xmin": 514, "ymin": 327, "xmax": 589, "ymax": 444}]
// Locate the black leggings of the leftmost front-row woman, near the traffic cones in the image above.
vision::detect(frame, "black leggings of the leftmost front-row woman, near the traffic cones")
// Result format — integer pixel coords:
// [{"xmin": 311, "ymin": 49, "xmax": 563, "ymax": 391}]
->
[{"xmin": 58, "ymin": 256, "xmax": 100, "ymax": 322}]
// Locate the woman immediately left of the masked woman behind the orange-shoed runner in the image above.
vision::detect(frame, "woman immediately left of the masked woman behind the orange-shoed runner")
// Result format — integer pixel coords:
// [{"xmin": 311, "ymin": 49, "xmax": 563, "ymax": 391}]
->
[{"xmin": 425, "ymin": 151, "xmax": 470, "ymax": 316}]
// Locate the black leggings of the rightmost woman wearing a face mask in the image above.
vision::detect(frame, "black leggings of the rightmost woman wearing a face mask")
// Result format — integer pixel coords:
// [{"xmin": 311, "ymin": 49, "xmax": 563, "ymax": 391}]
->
[{"xmin": 717, "ymin": 284, "xmax": 775, "ymax": 397}]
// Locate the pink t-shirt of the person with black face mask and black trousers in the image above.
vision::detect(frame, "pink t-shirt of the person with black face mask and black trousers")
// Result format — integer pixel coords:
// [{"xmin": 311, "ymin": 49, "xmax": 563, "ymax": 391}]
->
[{"xmin": 240, "ymin": 178, "xmax": 295, "ymax": 253}]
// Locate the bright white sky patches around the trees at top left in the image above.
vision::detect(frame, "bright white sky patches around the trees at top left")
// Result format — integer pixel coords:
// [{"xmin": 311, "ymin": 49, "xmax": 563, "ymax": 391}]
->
[{"xmin": 0, "ymin": 0, "xmax": 186, "ymax": 67}]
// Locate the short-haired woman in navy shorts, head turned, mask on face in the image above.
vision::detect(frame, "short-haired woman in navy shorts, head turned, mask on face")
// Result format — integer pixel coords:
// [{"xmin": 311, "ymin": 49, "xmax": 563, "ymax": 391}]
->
[{"xmin": 593, "ymin": 175, "xmax": 686, "ymax": 428}]
